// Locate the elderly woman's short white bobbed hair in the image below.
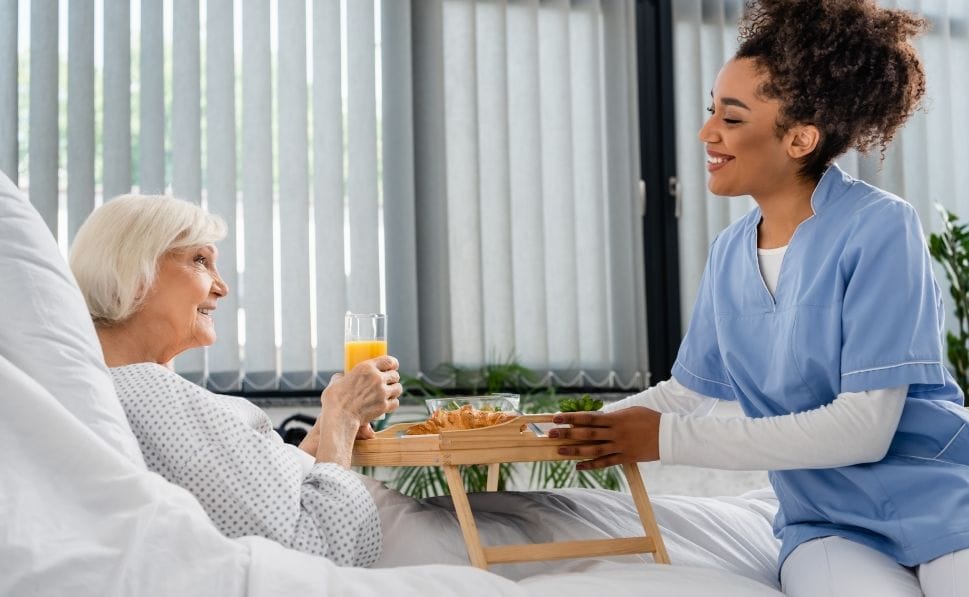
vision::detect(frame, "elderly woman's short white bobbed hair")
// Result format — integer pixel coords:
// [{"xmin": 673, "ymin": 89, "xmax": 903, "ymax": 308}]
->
[{"xmin": 70, "ymin": 195, "xmax": 226, "ymax": 325}]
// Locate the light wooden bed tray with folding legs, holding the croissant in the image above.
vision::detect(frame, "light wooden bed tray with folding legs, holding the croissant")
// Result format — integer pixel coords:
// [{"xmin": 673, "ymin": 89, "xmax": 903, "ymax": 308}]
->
[{"xmin": 353, "ymin": 414, "xmax": 670, "ymax": 569}]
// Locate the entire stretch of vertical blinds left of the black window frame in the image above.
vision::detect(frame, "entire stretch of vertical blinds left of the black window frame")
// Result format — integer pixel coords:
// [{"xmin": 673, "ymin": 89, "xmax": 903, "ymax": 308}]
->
[{"xmin": 0, "ymin": 0, "xmax": 648, "ymax": 391}]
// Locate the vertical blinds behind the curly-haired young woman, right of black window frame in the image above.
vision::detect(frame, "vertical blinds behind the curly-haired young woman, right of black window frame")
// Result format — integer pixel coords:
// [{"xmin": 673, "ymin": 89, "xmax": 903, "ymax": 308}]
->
[{"xmin": 673, "ymin": 0, "xmax": 969, "ymax": 336}]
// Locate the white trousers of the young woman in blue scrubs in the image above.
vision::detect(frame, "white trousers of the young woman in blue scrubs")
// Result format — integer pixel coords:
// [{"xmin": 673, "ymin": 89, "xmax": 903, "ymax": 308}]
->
[{"xmin": 781, "ymin": 537, "xmax": 969, "ymax": 597}]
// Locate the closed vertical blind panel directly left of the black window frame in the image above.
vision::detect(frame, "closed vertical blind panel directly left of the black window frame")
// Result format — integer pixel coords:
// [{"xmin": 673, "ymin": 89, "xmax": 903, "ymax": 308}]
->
[{"xmin": 413, "ymin": 0, "xmax": 646, "ymax": 387}]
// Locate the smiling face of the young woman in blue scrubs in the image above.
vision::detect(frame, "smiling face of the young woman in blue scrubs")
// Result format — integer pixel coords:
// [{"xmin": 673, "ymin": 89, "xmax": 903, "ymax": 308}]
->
[{"xmin": 699, "ymin": 58, "xmax": 797, "ymax": 198}]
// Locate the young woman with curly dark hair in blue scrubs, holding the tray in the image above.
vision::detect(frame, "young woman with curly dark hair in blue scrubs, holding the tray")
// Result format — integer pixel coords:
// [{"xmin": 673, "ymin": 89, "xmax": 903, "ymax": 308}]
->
[{"xmin": 557, "ymin": 0, "xmax": 969, "ymax": 597}]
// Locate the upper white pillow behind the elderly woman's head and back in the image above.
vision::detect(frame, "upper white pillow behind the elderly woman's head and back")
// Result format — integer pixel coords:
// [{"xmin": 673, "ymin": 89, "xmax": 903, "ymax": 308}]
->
[{"xmin": 0, "ymin": 173, "xmax": 145, "ymax": 467}]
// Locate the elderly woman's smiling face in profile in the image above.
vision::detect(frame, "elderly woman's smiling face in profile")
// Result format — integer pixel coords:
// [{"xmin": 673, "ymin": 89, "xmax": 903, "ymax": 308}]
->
[{"xmin": 137, "ymin": 245, "xmax": 228, "ymax": 357}]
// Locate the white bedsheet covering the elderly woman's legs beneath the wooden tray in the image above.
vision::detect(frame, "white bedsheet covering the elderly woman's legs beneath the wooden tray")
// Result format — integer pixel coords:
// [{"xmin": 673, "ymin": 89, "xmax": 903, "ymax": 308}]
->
[{"xmin": 368, "ymin": 480, "xmax": 779, "ymax": 588}]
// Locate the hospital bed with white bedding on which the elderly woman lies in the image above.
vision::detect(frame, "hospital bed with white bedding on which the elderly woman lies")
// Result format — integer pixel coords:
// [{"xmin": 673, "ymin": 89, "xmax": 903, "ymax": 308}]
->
[{"xmin": 0, "ymin": 169, "xmax": 781, "ymax": 597}]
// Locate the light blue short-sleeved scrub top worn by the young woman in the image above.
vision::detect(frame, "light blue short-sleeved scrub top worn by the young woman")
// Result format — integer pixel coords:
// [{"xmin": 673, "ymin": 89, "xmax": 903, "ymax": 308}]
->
[{"xmin": 673, "ymin": 166, "xmax": 969, "ymax": 566}]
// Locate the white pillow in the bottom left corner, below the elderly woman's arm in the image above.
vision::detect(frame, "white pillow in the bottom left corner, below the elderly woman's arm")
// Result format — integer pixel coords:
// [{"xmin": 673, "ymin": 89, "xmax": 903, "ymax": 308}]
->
[{"xmin": 0, "ymin": 356, "xmax": 249, "ymax": 597}]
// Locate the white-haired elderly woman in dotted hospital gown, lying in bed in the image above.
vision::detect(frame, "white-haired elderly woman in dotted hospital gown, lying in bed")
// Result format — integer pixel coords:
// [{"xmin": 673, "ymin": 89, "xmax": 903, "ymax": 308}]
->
[{"xmin": 70, "ymin": 196, "xmax": 402, "ymax": 566}]
